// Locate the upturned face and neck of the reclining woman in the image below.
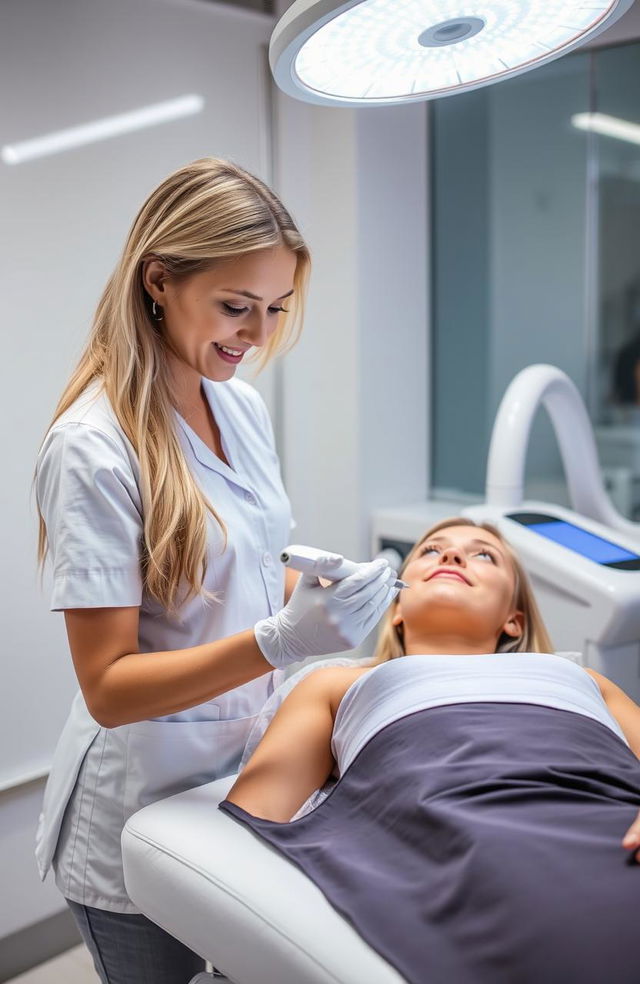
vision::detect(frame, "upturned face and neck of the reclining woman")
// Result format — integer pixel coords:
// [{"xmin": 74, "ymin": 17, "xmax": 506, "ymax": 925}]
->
[{"xmin": 393, "ymin": 526, "xmax": 523, "ymax": 654}]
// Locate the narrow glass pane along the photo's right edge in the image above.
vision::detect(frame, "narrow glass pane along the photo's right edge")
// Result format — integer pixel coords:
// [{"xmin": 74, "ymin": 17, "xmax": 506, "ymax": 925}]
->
[{"xmin": 590, "ymin": 45, "xmax": 640, "ymax": 520}]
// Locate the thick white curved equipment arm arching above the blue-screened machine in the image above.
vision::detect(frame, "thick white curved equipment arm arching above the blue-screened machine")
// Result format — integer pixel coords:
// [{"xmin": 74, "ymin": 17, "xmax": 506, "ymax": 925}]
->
[{"xmin": 486, "ymin": 364, "xmax": 640, "ymax": 537}]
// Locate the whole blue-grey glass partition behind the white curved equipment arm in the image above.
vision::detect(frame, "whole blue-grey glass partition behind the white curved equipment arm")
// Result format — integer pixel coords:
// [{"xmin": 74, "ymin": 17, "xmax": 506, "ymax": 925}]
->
[{"xmin": 431, "ymin": 44, "xmax": 640, "ymax": 518}]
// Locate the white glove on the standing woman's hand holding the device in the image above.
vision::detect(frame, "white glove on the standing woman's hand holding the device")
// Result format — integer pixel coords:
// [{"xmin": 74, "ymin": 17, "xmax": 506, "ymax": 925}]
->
[{"xmin": 254, "ymin": 554, "xmax": 399, "ymax": 666}]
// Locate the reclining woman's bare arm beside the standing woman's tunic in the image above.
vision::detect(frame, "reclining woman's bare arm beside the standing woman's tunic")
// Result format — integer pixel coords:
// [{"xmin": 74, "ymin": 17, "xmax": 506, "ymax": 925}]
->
[{"xmin": 227, "ymin": 667, "xmax": 362, "ymax": 822}]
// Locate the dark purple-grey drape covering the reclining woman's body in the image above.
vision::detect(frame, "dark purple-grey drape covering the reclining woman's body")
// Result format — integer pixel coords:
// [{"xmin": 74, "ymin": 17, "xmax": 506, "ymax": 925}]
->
[{"xmin": 220, "ymin": 703, "xmax": 640, "ymax": 984}]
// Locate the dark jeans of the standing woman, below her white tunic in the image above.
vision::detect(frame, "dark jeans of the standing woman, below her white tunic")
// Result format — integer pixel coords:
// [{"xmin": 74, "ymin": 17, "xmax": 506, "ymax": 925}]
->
[{"xmin": 66, "ymin": 899, "xmax": 205, "ymax": 984}]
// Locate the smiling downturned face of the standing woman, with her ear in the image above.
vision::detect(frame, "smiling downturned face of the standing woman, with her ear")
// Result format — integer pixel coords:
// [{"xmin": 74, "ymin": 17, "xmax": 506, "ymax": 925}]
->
[{"xmin": 142, "ymin": 246, "xmax": 296, "ymax": 404}]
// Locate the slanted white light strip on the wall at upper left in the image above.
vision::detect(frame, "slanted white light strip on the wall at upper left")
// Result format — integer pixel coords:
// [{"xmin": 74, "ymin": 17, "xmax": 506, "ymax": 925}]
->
[{"xmin": 0, "ymin": 95, "xmax": 204, "ymax": 164}]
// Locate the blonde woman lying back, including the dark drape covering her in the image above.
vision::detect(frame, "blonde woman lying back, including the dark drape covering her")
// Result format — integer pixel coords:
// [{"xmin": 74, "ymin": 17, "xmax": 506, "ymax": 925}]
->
[{"xmin": 220, "ymin": 518, "xmax": 640, "ymax": 984}]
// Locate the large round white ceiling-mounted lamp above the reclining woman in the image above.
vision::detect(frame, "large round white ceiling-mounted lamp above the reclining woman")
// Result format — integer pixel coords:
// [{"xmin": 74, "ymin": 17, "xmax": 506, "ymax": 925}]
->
[{"xmin": 269, "ymin": 0, "xmax": 633, "ymax": 106}]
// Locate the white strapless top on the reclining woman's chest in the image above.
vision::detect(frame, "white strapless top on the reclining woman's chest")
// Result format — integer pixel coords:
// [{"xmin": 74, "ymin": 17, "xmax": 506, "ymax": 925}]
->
[{"xmin": 331, "ymin": 653, "xmax": 628, "ymax": 775}]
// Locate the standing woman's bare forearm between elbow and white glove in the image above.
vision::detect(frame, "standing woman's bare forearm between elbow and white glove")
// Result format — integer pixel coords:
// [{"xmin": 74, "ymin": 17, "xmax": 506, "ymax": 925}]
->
[{"xmin": 94, "ymin": 629, "xmax": 273, "ymax": 728}]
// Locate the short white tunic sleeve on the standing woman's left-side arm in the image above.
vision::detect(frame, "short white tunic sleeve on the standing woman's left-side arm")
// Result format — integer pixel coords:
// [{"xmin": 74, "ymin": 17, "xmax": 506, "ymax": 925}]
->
[{"xmin": 36, "ymin": 423, "xmax": 143, "ymax": 612}]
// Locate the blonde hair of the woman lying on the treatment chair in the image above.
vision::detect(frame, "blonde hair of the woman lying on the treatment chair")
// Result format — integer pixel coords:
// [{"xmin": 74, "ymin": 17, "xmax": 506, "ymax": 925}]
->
[{"xmin": 372, "ymin": 516, "xmax": 554, "ymax": 665}]
